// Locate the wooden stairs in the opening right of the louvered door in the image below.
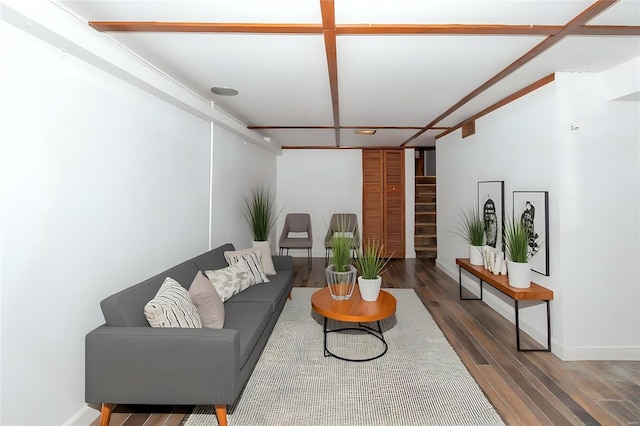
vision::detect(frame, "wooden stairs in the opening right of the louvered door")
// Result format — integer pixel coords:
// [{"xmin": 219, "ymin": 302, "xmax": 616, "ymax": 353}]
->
[{"xmin": 414, "ymin": 176, "xmax": 438, "ymax": 258}]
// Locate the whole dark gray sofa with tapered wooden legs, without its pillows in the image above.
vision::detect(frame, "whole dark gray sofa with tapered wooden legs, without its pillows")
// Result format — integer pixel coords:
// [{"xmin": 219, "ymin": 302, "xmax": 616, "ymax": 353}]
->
[{"xmin": 85, "ymin": 244, "xmax": 293, "ymax": 425}]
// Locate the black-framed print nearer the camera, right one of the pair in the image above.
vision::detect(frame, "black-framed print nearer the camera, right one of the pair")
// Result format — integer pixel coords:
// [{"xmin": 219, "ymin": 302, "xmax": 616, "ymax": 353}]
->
[{"xmin": 513, "ymin": 191, "xmax": 549, "ymax": 276}]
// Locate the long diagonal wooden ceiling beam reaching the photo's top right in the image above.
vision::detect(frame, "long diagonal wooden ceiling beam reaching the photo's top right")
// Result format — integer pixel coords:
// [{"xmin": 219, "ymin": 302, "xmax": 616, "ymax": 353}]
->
[{"xmin": 400, "ymin": 0, "xmax": 619, "ymax": 146}]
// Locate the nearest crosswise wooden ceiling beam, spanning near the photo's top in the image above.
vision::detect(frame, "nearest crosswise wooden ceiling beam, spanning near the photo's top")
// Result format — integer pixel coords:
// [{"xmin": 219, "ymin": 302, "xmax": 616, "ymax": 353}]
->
[{"xmin": 89, "ymin": 21, "xmax": 640, "ymax": 36}]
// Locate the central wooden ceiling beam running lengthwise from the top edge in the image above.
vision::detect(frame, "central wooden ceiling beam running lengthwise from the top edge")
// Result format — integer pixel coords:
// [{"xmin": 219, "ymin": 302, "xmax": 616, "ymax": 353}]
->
[{"xmin": 320, "ymin": 0, "xmax": 340, "ymax": 146}]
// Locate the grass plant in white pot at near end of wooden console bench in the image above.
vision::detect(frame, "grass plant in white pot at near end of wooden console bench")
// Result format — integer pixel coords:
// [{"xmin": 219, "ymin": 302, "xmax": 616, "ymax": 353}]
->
[{"xmin": 504, "ymin": 215, "xmax": 539, "ymax": 288}]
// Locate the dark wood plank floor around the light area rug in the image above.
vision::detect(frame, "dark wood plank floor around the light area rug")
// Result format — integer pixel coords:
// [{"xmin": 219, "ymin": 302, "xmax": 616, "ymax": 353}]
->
[{"xmin": 92, "ymin": 258, "xmax": 640, "ymax": 426}]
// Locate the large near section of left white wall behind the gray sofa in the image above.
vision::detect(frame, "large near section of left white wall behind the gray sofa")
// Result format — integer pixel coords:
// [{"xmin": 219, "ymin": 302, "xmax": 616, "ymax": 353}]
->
[{"xmin": 0, "ymin": 15, "xmax": 210, "ymax": 425}]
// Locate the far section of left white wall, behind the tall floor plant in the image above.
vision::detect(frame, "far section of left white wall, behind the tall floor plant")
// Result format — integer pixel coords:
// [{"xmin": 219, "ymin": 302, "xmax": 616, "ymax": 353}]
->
[{"xmin": 211, "ymin": 127, "xmax": 280, "ymax": 251}]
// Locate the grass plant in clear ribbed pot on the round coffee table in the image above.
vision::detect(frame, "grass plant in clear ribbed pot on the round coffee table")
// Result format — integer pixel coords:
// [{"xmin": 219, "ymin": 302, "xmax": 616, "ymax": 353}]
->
[{"xmin": 325, "ymin": 216, "xmax": 357, "ymax": 300}]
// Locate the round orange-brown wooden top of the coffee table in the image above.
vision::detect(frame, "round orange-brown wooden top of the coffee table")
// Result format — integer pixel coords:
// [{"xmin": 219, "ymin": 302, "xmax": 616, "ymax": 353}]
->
[{"xmin": 311, "ymin": 285, "xmax": 396, "ymax": 322}]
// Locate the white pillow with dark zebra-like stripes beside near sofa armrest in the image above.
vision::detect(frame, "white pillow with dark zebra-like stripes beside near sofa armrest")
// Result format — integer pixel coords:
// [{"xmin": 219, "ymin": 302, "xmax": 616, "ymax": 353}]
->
[{"xmin": 144, "ymin": 277, "xmax": 202, "ymax": 328}]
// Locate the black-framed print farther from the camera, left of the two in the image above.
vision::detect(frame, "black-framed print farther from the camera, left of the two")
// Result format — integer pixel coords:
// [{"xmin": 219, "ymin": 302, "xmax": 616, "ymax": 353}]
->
[{"xmin": 478, "ymin": 180, "xmax": 504, "ymax": 250}]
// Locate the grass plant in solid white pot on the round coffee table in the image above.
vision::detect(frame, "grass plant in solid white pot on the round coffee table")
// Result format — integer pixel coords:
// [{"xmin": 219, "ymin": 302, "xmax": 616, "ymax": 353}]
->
[{"xmin": 354, "ymin": 239, "xmax": 389, "ymax": 302}]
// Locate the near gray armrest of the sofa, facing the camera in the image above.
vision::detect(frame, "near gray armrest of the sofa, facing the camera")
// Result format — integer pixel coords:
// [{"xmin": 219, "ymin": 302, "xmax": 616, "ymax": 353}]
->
[{"xmin": 85, "ymin": 325, "xmax": 241, "ymax": 405}]
